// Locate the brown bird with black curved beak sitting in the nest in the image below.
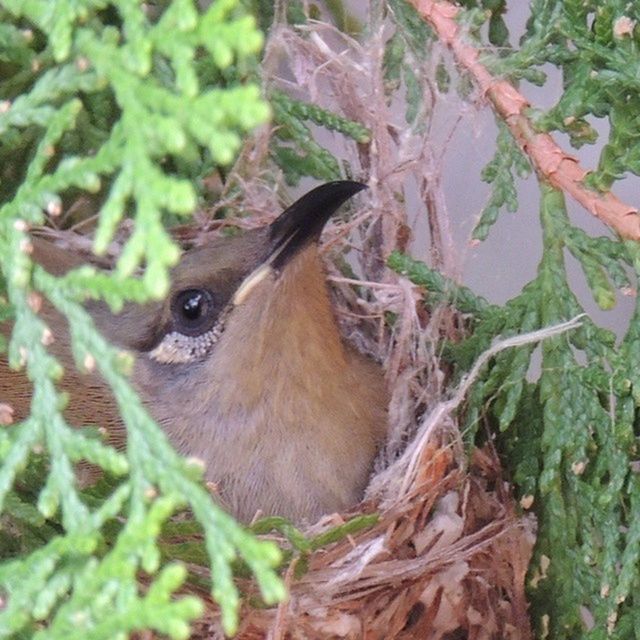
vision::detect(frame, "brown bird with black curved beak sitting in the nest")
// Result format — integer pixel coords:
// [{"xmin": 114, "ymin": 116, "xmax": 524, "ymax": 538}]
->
[{"xmin": 0, "ymin": 180, "xmax": 388, "ymax": 523}]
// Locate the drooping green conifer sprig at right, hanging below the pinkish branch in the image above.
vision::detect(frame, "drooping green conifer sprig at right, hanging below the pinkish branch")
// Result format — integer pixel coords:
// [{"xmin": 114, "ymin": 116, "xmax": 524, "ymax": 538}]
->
[{"xmin": 389, "ymin": 180, "xmax": 640, "ymax": 638}]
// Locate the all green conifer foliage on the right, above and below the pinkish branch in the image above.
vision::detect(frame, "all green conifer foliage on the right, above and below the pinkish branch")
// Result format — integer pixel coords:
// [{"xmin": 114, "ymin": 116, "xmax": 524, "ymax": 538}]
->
[{"xmin": 389, "ymin": 0, "xmax": 640, "ymax": 640}]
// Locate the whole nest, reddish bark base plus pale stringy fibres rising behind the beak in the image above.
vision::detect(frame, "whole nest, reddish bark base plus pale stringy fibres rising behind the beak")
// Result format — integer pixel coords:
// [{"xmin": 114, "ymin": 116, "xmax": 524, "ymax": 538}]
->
[{"xmin": 164, "ymin": 17, "xmax": 535, "ymax": 640}]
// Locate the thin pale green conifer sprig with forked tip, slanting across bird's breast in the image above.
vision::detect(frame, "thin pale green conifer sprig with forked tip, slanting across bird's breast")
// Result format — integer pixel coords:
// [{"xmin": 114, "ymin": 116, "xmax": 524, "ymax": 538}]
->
[{"xmin": 36, "ymin": 271, "xmax": 285, "ymax": 632}]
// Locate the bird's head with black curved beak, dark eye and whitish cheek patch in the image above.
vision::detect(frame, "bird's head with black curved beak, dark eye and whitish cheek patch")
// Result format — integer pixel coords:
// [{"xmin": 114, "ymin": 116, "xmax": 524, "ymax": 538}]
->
[{"xmin": 94, "ymin": 181, "xmax": 365, "ymax": 376}]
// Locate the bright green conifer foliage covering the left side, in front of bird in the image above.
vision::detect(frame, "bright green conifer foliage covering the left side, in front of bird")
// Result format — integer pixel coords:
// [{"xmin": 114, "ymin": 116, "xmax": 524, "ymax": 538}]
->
[{"xmin": 0, "ymin": 0, "xmax": 284, "ymax": 638}]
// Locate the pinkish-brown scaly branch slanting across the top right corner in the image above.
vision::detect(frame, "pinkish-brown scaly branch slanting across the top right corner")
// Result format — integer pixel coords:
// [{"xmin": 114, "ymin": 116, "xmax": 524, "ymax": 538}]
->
[{"xmin": 410, "ymin": 0, "xmax": 640, "ymax": 240}]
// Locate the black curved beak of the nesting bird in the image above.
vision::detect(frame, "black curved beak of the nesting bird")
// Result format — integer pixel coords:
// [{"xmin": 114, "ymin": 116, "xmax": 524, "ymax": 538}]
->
[{"xmin": 268, "ymin": 180, "xmax": 367, "ymax": 270}]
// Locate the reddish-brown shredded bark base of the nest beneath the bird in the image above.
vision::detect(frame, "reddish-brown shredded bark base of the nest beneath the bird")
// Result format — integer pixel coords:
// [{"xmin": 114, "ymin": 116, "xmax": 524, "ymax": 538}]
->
[{"xmin": 186, "ymin": 443, "xmax": 535, "ymax": 640}]
